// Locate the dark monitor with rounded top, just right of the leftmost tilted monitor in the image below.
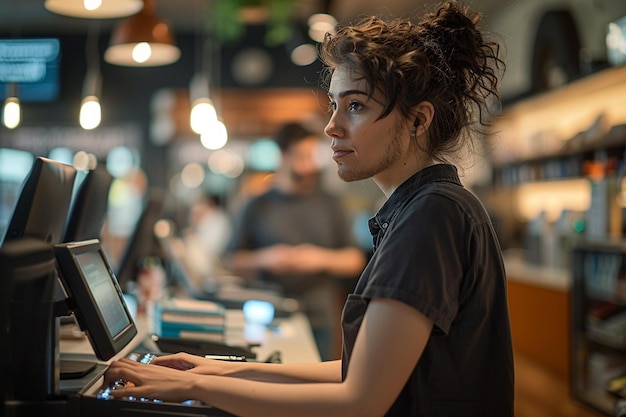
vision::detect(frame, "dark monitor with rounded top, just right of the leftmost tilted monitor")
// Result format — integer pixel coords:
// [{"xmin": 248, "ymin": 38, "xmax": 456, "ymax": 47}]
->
[{"xmin": 61, "ymin": 165, "xmax": 113, "ymax": 242}]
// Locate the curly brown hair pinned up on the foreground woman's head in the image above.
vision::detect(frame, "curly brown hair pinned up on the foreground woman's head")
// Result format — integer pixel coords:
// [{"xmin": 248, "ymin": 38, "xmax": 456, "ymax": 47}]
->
[{"xmin": 320, "ymin": 1, "xmax": 505, "ymax": 161}]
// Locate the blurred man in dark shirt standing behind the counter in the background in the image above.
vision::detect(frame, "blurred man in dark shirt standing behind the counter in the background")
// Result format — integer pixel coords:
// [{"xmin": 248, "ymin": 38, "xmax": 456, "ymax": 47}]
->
[{"xmin": 224, "ymin": 123, "xmax": 366, "ymax": 360}]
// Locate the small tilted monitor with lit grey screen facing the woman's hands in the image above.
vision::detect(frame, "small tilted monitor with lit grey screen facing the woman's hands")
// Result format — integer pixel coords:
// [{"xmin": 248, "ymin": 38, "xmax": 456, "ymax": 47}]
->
[{"xmin": 55, "ymin": 239, "xmax": 137, "ymax": 360}]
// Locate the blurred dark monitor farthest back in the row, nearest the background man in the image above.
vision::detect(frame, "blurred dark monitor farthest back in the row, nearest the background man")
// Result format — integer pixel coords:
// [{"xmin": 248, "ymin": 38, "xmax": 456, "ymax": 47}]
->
[{"xmin": 117, "ymin": 190, "xmax": 163, "ymax": 292}]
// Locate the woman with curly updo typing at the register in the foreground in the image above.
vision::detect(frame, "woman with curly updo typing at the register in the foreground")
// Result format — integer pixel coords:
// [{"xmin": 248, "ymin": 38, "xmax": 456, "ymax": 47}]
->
[{"xmin": 105, "ymin": 2, "xmax": 513, "ymax": 417}]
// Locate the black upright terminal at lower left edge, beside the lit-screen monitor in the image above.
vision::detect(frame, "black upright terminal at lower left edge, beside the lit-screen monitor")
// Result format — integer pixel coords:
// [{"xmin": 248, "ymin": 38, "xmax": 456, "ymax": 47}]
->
[{"xmin": 0, "ymin": 237, "xmax": 59, "ymax": 402}]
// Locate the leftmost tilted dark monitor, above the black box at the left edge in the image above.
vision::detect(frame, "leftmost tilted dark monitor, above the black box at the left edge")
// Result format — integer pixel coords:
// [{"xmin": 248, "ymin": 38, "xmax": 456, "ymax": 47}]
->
[{"xmin": 4, "ymin": 157, "xmax": 76, "ymax": 244}]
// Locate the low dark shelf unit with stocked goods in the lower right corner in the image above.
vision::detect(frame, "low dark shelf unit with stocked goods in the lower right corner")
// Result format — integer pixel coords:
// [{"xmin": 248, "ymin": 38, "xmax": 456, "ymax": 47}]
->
[{"xmin": 570, "ymin": 242, "xmax": 626, "ymax": 416}]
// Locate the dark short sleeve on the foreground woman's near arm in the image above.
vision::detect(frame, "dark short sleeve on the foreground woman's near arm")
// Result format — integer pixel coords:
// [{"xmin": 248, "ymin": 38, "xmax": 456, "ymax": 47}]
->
[{"xmin": 363, "ymin": 193, "xmax": 467, "ymax": 333}]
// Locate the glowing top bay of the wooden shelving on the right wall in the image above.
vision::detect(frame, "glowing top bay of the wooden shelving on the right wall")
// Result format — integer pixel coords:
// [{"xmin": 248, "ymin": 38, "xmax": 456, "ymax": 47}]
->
[{"xmin": 492, "ymin": 66, "xmax": 626, "ymax": 165}]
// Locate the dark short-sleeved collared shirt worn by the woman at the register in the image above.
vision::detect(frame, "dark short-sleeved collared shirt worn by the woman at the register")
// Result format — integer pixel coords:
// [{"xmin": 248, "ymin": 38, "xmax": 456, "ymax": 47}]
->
[{"xmin": 342, "ymin": 165, "xmax": 513, "ymax": 417}]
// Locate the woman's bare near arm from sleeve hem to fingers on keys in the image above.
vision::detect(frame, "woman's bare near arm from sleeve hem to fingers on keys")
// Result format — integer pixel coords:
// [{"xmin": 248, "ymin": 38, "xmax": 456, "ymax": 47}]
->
[{"xmin": 105, "ymin": 299, "xmax": 432, "ymax": 417}]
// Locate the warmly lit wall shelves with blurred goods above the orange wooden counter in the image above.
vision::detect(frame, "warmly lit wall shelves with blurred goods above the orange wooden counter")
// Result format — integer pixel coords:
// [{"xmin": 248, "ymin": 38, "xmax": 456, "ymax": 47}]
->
[{"xmin": 490, "ymin": 66, "xmax": 626, "ymax": 249}]
